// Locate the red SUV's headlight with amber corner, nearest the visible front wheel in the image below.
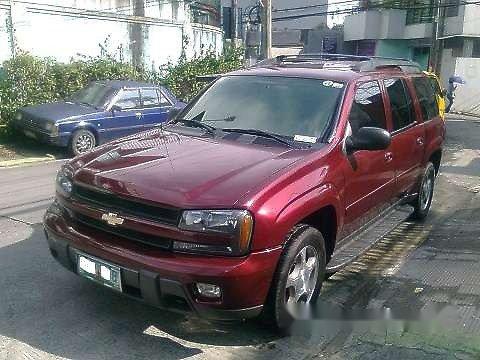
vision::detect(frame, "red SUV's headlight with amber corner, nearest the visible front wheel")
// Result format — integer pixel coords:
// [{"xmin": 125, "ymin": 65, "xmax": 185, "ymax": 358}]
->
[{"xmin": 173, "ymin": 210, "xmax": 253, "ymax": 256}]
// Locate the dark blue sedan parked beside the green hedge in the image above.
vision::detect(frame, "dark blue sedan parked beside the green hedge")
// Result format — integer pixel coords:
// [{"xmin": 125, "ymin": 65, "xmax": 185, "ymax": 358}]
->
[{"xmin": 14, "ymin": 81, "xmax": 185, "ymax": 155}]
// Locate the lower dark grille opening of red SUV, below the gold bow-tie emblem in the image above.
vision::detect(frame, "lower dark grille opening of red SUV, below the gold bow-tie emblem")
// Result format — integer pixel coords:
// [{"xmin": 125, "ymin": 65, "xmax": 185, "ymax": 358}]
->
[{"xmin": 74, "ymin": 213, "xmax": 172, "ymax": 250}]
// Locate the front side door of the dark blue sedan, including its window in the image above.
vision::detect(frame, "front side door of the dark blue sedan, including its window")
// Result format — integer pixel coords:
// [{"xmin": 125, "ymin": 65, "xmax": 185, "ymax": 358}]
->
[{"xmin": 100, "ymin": 88, "xmax": 144, "ymax": 142}]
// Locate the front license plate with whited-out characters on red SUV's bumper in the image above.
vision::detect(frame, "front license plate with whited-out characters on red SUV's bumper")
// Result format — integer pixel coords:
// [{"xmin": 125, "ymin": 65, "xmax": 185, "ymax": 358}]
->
[{"xmin": 77, "ymin": 253, "xmax": 122, "ymax": 291}]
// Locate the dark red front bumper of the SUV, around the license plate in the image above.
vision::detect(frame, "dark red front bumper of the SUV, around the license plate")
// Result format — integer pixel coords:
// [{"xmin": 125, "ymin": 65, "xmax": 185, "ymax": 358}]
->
[{"xmin": 44, "ymin": 202, "xmax": 281, "ymax": 320}]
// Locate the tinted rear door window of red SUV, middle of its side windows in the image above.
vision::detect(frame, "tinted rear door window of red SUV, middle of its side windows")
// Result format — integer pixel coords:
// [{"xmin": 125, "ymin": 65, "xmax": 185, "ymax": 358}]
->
[{"xmin": 384, "ymin": 79, "xmax": 415, "ymax": 130}]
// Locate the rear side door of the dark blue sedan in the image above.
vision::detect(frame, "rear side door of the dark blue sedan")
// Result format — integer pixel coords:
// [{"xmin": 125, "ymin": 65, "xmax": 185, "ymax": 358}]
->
[{"xmin": 140, "ymin": 88, "xmax": 172, "ymax": 129}]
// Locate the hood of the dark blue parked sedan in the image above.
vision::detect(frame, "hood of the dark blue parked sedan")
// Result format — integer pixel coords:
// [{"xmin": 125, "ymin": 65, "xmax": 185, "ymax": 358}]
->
[{"xmin": 21, "ymin": 101, "xmax": 99, "ymax": 121}]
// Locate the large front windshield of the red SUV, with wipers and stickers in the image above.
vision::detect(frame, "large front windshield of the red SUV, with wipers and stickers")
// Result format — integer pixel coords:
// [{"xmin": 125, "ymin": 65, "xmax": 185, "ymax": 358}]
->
[{"xmin": 178, "ymin": 75, "xmax": 345, "ymax": 143}]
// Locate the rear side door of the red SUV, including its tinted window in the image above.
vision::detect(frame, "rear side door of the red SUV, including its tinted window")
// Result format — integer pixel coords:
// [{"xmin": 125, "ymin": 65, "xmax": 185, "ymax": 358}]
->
[{"xmin": 384, "ymin": 78, "xmax": 425, "ymax": 196}]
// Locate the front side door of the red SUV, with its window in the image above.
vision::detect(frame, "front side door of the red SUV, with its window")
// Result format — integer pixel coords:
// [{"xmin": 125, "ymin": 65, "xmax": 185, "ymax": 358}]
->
[{"xmin": 344, "ymin": 81, "xmax": 395, "ymax": 235}]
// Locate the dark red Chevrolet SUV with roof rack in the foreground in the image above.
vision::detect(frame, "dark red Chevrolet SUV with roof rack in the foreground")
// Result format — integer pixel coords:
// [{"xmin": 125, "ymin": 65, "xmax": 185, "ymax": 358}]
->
[{"xmin": 44, "ymin": 55, "xmax": 445, "ymax": 328}]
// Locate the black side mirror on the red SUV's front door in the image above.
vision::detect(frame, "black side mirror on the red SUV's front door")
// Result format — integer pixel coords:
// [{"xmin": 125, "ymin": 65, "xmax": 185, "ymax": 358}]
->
[{"xmin": 345, "ymin": 127, "xmax": 392, "ymax": 154}]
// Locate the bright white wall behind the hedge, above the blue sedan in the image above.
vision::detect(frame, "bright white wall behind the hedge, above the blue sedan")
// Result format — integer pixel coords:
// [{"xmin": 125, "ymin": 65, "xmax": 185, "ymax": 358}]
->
[{"xmin": 0, "ymin": 0, "xmax": 223, "ymax": 67}]
